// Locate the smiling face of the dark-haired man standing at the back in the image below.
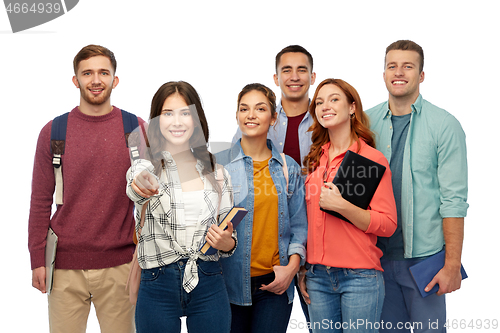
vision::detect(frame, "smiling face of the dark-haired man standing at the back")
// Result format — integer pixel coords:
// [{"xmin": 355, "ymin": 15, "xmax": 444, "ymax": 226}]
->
[{"xmin": 274, "ymin": 52, "xmax": 316, "ymax": 101}]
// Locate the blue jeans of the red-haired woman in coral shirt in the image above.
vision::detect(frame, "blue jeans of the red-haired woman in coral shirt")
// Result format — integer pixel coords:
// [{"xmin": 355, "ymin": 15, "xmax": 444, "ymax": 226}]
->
[{"xmin": 306, "ymin": 265, "xmax": 384, "ymax": 333}]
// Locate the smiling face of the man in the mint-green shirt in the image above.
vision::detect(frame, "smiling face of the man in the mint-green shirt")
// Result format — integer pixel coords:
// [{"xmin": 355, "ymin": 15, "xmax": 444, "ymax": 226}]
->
[{"xmin": 384, "ymin": 50, "xmax": 424, "ymax": 103}]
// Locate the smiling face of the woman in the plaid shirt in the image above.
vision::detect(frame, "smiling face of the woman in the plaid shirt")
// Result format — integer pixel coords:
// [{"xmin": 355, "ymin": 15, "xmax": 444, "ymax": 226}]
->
[{"xmin": 159, "ymin": 93, "xmax": 195, "ymax": 153}]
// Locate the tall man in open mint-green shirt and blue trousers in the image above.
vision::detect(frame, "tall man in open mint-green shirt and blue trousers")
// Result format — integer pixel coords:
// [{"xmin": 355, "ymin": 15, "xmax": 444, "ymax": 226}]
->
[{"xmin": 367, "ymin": 40, "xmax": 468, "ymax": 332}]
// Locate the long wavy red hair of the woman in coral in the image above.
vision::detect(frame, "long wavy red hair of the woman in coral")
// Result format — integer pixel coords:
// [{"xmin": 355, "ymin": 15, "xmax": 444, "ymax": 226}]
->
[{"xmin": 303, "ymin": 79, "xmax": 375, "ymax": 174}]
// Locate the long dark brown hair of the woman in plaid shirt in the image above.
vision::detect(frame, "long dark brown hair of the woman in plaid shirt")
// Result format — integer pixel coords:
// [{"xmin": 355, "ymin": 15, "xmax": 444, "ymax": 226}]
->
[{"xmin": 148, "ymin": 81, "xmax": 219, "ymax": 191}]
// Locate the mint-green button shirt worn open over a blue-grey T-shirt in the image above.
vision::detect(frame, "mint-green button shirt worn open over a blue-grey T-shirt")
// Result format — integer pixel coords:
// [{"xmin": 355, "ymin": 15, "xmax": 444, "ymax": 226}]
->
[{"xmin": 366, "ymin": 95, "xmax": 469, "ymax": 258}]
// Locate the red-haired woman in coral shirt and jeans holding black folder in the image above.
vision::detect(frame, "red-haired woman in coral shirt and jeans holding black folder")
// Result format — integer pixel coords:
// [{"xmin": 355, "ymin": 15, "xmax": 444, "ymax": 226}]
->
[{"xmin": 299, "ymin": 79, "xmax": 396, "ymax": 332}]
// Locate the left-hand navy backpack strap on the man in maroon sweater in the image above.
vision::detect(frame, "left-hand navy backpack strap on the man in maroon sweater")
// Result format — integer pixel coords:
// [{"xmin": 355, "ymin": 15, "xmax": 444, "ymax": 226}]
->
[{"xmin": 50, "ymin": 112, "xmax": 69, "ymax": 205}]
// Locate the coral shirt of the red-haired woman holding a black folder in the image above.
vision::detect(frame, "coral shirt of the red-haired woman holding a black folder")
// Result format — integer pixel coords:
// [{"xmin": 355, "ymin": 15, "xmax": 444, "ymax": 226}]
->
[{"xmin": 305, "ymin": 139, "xmax": 397, "ymax": 271}]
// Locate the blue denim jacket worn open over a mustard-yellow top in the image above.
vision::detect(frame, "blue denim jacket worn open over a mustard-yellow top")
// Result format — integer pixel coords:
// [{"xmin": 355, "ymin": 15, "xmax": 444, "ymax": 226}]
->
[{"xmin": 215, "ymin": 139, "xmax": 307, "ymax": 306}]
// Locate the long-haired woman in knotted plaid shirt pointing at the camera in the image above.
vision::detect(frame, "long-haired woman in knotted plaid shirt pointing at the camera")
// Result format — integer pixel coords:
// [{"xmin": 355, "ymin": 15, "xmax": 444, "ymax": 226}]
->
[{"xmin": 127, "ymin": 81, "xmax": 236, "ymax": 333}]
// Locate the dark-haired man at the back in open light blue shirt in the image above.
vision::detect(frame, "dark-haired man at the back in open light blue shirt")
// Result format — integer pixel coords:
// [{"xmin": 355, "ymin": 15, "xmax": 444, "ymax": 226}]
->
[{"xmin": 233, "ymin": 45, "xmax": 316, "ymax": 165}]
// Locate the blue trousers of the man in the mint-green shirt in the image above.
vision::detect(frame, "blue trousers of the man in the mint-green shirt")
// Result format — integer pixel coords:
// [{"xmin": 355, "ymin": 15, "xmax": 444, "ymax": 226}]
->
[{"xmin": 380, "ymin": 259, "xmax": 446, "ymax": 333}]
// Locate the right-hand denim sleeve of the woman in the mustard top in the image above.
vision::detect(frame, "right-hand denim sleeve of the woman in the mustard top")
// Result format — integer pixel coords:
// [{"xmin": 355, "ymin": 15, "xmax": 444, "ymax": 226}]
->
[{"xmin": 286, "ymin": 156, "xmax": 307, "ymax": 266}]
